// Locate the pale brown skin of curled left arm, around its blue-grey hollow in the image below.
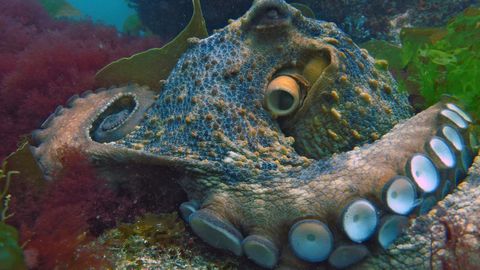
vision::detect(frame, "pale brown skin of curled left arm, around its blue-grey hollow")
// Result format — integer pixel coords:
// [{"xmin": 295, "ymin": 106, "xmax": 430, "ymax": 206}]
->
[{"xmin": 31, "ymin": 85, "xmax": 155, "ymax": 178}]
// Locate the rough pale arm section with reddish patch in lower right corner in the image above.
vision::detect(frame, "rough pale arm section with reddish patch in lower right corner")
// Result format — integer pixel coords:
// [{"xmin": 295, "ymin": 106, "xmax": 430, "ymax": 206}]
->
[{"xmin": 360, "ymin": 152, "xmax": 480, "ymax": 270}]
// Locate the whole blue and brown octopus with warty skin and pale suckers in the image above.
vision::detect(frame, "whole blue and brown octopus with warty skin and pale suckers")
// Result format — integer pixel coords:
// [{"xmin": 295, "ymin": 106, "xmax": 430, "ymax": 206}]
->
[{"xmin": 31, "ymin": 0, "xmax": 480, "ymax": 269}]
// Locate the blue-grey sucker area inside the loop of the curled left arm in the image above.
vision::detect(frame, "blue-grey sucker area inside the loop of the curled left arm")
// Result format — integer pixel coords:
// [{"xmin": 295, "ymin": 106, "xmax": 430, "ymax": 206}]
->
[{"xmin": 90, "ymin": 95, "xmax": 138, "ymax": 142}]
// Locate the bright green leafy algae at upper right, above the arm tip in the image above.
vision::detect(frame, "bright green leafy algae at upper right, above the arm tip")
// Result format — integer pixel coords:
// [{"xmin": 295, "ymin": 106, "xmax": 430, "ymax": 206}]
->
[{"xmin": 362, "ymin": 7, "xmax": 480, "ymax": 119}]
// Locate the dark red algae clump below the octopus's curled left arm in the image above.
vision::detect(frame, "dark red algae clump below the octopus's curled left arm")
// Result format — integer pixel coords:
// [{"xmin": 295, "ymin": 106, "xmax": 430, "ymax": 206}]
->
[{"xmin": 16, "ymin": 150, "xmax": 136, "ymax": 269}]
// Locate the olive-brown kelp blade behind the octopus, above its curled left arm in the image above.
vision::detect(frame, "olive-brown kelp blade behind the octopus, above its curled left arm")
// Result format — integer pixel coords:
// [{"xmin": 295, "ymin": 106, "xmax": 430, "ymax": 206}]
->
[{"xmin": 95, "ymin": 0, "xmax": 208, "ymax": 89}]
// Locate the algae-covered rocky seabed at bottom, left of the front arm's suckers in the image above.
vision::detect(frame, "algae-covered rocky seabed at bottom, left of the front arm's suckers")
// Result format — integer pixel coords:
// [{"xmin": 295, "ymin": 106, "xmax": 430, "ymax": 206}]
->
[{"xmin": 82, "ymin": 212, "xmax": 260, "ymax": 270}]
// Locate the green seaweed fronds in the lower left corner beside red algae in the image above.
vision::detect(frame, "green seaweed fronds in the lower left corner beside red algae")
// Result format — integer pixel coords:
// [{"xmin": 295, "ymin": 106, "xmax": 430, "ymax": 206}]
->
[{"xmin": 0, "ymin": 161, "xmax": 26, "ymax": 270}]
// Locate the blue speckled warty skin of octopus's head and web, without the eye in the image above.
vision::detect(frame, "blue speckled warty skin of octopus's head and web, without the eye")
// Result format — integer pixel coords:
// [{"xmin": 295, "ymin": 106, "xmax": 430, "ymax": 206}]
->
[{"xmin": 119, "ymin": 1, "xmax": 411, "ymax": 188}]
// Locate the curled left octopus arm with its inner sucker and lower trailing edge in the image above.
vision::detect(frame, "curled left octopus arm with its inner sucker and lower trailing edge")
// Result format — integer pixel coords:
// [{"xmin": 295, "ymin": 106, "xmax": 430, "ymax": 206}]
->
[{"xmin": 30, "ymin": 84, "xmax": 212, "ymax": 182}]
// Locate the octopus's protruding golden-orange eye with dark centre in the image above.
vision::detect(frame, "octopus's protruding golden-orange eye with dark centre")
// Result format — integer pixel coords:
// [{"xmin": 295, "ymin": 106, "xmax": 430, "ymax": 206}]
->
[{"xmin": 264, "ymin": 75, "xmax": 301, "ymax": 117}]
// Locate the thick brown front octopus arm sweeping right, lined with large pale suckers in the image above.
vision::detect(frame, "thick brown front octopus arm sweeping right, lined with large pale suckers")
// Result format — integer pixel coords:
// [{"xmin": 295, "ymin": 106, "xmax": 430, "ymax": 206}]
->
[{"xmin": 188, "ymin": 103, "xmax": 474, "ymax": 268}]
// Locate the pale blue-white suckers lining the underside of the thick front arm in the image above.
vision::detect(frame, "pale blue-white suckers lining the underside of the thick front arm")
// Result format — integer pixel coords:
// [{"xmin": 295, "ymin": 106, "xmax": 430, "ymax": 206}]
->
[{"xmin": 180, "ymin": 103, "xmax": 476, "ymax": 269}]
